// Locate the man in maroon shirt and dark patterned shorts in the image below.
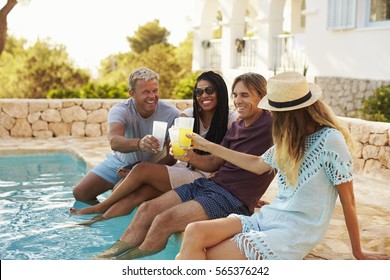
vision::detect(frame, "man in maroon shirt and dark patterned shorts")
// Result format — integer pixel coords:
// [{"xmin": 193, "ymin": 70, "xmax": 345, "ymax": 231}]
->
[{"xmin": 96, "ymin": 73, "xmax": 275, "ymax": 259}]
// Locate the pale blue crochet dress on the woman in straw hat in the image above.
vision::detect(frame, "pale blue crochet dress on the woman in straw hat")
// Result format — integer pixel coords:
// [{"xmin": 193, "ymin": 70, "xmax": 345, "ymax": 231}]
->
[{"xmin": 229, "ymin": 127, "xmax": 352, "ymax": 260}]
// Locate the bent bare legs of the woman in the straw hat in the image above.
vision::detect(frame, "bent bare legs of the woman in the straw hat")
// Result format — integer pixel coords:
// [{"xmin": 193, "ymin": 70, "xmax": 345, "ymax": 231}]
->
[{"xmin": 176, "ymin": 218, "xmax": 245, "ymax": 260}]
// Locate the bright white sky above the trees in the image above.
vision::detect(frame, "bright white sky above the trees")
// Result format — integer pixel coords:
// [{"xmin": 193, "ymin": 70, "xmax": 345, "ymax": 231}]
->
[{"xmin": 0, "ymin": 0, "xmax": 194, "ymax": 72}]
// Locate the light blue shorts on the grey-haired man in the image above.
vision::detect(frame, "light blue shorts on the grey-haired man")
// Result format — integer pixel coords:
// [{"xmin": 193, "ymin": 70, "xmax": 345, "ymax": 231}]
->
[{"xmin": 91, "ymin": 154, "xmax": 127, "ymax": 185}]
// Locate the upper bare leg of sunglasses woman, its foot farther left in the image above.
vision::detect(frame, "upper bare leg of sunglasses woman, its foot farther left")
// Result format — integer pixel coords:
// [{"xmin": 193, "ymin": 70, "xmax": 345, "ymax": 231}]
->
[{"xmin": 70, "ymin": 162, "xmax": 171, "ymax": 215}]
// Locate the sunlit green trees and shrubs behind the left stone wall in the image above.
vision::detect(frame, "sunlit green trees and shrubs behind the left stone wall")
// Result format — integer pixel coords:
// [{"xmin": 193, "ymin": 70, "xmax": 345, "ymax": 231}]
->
[{"xmin": 0, "ymin": 20, "xmax": 193, "ymax": 98}]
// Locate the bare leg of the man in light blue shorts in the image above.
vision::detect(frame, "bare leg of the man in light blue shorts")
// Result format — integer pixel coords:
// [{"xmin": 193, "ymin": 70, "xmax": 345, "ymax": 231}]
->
[{"xmin": 73, "ymin": 172, "xmax": 114, "ymax": 204}]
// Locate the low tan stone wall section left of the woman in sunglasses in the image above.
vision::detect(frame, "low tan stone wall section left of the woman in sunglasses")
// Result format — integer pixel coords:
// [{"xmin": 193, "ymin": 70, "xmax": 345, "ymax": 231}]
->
[{"xmin": 0, "ymin": 99, "xmax": 192, "ymax": 138}]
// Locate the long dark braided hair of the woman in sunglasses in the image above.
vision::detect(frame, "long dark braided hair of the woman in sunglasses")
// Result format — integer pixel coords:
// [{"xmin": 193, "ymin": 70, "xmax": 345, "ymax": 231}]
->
[{"xmin": 192, "ymin": 71, "xmax": 229, "ymax": 154}]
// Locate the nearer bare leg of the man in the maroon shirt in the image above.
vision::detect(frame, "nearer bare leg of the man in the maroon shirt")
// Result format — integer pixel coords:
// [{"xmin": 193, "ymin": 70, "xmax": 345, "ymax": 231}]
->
[{"xmin": 121, "ymin": 200, "xmax": 208, "ymax": 259}]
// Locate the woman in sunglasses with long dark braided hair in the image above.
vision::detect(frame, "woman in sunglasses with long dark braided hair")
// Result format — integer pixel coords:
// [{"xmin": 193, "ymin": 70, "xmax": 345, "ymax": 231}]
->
[{"xmin": 70, "ymin": 71, "xmax": 238, "ymax": 225}]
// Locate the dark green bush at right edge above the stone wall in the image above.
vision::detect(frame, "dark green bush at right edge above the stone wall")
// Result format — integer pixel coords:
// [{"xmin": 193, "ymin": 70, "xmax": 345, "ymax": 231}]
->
[{"xmin": 360, "ymin": 85, "xmax": 390, "ymax": 122}]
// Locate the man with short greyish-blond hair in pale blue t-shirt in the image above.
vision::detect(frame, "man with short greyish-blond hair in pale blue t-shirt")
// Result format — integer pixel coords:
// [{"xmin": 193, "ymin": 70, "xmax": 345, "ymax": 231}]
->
[{"xmin": 73, "ymin": 67, "xmax": 180, "ymax": 204}]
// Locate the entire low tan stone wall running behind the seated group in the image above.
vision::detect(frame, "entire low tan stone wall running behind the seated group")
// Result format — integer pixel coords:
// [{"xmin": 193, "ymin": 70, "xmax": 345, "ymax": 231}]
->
[{"xmin": 0, "ymin": 99, "xmax": 390, "ymax": 180}]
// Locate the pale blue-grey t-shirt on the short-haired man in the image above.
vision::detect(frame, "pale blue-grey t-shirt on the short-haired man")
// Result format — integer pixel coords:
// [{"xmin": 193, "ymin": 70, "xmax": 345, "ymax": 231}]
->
[{"xmin": 108, "ymin": 98, "xmax": 180, "ymax": 164}]
